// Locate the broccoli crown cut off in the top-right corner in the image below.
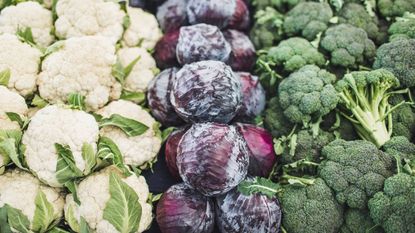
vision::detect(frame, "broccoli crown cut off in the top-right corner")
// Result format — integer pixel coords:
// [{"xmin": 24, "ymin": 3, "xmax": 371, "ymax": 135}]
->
[{"xmin": 378, "ymin": 0, "xmax": 415, "ymax": 17}]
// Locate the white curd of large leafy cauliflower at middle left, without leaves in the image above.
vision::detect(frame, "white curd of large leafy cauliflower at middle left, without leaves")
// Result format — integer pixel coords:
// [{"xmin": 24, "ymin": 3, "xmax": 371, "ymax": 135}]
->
[{"xmin": 22, "ymin": 105, "xmax": 99, "ymax": 187}]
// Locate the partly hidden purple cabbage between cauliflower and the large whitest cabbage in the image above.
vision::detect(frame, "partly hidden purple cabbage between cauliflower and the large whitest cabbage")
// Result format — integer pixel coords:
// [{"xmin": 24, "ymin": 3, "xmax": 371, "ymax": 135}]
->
[{"xmin": 147, "ymin": 68, "xmax": 184, "ymax": 126}]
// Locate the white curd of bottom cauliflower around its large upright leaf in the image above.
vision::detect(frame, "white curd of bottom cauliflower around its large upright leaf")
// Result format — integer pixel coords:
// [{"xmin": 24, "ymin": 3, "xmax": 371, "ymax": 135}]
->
[{"xmin": 65, "ymin": 166, "xmax": 153, "ymax": 233}]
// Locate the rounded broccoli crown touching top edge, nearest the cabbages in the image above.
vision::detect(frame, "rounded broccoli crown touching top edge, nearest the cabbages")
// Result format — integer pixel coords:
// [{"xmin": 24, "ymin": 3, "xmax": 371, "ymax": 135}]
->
[{"xmin": 284, "ymin": 2, "xmax": 333, "ymax": 41}]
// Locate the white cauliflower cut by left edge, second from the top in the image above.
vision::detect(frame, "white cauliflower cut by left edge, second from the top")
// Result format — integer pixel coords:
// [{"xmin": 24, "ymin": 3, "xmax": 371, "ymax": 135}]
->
[{"xmin": 0, "ymin": 34, "xmax": 42, "ymax": 96}]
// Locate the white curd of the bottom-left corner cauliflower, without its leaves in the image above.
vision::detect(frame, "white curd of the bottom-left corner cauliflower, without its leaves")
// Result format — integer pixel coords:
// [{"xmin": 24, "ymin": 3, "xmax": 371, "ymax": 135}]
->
[{"xmin": 0, "ymin": 170, "xmax": 64, "ymax": 232}]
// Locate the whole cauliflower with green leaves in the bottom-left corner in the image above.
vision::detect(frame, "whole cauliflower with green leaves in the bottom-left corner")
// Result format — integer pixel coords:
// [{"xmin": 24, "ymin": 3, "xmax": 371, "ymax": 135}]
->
[{"xmin": 0, "ymin": 170, "xmax": 64, "ymax": 233}]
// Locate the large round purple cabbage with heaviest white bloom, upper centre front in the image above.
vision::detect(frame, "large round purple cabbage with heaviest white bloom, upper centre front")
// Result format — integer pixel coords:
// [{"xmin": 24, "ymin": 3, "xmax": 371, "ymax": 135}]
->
[{"xmin": 170, "ymin": 61, "xmax": 242, "ymax": 123}]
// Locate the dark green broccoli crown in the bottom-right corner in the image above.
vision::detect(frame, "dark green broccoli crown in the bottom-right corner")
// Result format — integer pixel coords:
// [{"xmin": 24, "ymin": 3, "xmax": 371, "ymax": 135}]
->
[{"xmin": 369, "ymin": 173, "xmax": 415, "ymax": 233}]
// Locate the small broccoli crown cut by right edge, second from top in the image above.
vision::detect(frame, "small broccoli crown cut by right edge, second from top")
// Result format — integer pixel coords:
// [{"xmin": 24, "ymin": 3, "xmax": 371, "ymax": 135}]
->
[{"xmin": 388, "ymin": 12, "xmax": 415, "ymax": 41}]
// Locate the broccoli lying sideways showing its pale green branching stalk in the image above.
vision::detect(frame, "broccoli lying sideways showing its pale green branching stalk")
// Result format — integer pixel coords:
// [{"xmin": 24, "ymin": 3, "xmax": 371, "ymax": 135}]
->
[{"xmin": 336, "ymin": 69, "xmax": 399, "ymax": 147}]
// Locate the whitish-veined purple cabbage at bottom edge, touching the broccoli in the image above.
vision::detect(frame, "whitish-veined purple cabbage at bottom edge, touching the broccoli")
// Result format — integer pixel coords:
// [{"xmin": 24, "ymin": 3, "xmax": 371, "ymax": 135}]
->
[{"xmin": 215, "ymin": 178, "xmax": 281, "ymax": 233}]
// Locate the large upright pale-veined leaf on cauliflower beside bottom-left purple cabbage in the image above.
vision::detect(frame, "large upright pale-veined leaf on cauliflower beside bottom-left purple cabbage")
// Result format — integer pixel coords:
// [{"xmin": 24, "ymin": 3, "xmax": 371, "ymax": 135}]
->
[{"xmin": 103, "ymin": 173, "xmax": 142, "ymax": 233}]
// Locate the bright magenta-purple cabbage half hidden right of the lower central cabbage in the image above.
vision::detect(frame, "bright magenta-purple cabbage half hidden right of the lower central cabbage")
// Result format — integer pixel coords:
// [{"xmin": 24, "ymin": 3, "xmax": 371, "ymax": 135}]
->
[{"xmin": 237, "ymin": 123, "xmax": 276, "ymax": 177}]
